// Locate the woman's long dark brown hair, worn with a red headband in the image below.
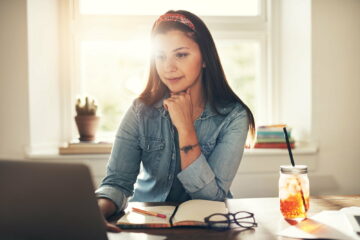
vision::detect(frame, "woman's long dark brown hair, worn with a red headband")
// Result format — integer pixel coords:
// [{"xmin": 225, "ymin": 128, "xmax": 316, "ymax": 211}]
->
[{"xmin": 139, "ymin": 10, "xmax": 255, "ymax": 140}]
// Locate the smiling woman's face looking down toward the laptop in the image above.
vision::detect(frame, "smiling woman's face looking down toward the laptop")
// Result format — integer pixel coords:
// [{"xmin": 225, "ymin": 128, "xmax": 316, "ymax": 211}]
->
[{"xmin": 154, "ymin": 30, "xmax": 203, "ymax": 93}]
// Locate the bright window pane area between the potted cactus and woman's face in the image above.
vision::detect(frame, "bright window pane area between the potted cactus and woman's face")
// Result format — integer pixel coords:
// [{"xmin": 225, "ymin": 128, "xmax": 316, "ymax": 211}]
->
[{"xmin": 80, "ymin": 37, "xmax": 149, "ymax": 137}]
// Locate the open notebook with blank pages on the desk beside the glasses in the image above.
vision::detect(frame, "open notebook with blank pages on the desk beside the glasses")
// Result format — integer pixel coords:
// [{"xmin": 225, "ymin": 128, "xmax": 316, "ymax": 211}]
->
[{"xmin": 116, "ymin": 200, "xmax": 228, "ymax": 229}]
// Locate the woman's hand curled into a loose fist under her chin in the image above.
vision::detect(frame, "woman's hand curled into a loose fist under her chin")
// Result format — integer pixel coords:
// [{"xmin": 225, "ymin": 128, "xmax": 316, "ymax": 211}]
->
[{"xmin": 163, "ymin": 88, "xmax": 193, "ymax": 131}]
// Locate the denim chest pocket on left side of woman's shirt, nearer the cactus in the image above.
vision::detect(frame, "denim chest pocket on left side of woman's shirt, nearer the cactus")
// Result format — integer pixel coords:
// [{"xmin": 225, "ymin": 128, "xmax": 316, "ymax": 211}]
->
[{"xmin": 140, "ymin": 137, "xmax": 165, "ymax": 175}]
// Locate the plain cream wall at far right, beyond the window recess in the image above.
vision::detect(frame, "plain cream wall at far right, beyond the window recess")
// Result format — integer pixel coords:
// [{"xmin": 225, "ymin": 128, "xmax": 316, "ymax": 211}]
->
[{"xmin": 312, "ymin": 0, "xmax": 360, "ymax": 194}]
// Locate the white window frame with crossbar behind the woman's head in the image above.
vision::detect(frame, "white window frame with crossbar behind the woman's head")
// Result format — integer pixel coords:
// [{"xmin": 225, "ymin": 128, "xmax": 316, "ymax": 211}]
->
[{"xmin": 61, "ymin": 0, "xmax": 279, "ymax": 141}]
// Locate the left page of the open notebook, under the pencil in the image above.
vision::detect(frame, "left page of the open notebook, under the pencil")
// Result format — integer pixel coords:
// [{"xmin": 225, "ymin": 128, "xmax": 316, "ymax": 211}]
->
[{"xmin": 116, "ymin": 206, "xmax": 175, "ymax": 225}]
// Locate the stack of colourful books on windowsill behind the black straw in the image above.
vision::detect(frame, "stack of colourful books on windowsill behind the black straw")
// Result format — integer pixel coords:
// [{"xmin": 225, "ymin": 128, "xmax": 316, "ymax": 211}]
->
[{"xmin": 254, "ymin": 124, "xmax": 295, "ymax": 148}]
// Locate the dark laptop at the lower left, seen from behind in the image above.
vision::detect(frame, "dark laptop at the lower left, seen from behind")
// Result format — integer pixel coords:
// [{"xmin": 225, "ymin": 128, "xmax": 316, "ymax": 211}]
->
[{"xmin": 0, "ymin": 160, "xmax": 107, "ymax": 240}]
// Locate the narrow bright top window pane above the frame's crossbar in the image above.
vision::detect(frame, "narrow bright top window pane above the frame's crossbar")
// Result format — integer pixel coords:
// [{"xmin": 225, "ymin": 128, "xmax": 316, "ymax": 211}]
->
[{"xmin": 80, "ymin": 0, "xmax": 260, "ymax": 16}]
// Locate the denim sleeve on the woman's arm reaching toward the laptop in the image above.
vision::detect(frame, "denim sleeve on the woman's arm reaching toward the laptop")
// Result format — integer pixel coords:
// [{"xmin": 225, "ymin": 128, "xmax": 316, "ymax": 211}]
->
[{"xmin": 95, "ymin": 102, "xmax": 141, "ymax": 211}]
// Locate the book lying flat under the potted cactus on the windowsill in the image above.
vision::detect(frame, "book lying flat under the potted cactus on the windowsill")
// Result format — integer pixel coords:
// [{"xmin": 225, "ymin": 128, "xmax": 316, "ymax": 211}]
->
[{"xmin": 59, "ymin": 141, "xmax": 112, "ymax": 155}]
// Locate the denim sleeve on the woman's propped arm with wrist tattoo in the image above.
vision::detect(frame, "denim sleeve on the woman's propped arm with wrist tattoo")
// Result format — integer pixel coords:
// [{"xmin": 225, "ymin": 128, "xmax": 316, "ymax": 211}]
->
[{"xmin": 177, "ymin": 110, "xmax": 249, "ymax": 201}]
